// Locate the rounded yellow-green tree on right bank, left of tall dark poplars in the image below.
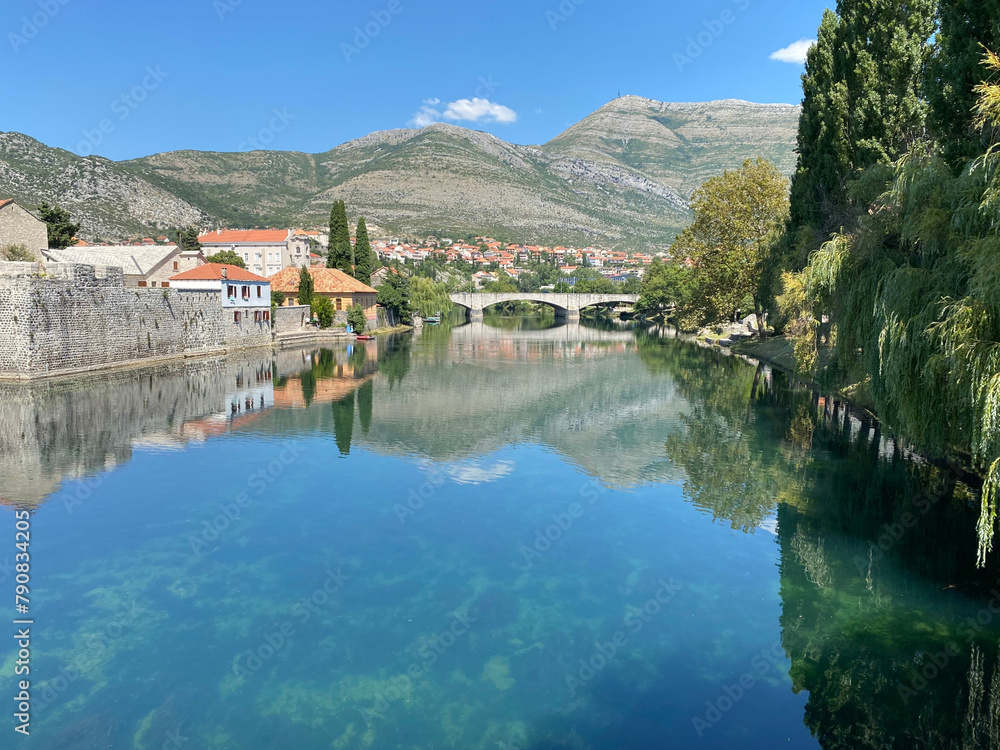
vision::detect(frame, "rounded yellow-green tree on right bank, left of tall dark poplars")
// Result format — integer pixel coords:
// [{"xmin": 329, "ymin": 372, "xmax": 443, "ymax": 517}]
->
[{"xmin": 671, "ymin": 159, "xmax": 788, "ymax": 328}]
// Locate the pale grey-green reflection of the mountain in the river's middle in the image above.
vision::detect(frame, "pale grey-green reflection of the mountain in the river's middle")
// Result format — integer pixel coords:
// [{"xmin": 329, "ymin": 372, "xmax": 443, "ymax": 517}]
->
[{"xmin": 254, "ymin": 324, "xmax": 685, "ymax": 486}]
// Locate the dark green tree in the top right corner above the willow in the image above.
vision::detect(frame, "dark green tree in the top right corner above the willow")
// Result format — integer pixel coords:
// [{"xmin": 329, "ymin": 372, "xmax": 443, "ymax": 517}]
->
[{"xmin": 927, "ymin": 0, "xmax": 1000, "ymax": 172}]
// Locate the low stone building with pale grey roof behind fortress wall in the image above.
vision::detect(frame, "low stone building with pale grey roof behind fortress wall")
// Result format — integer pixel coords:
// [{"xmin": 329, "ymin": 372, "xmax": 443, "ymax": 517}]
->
[{"xmin": 43, "ymin": 245, "xmax": 205, "ymax": 287}]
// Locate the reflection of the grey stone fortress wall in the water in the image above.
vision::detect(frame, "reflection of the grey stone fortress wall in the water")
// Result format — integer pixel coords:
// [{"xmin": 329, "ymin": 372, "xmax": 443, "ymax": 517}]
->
[{"xmin": 0, "ymin": 351, "xmax": 272, "ymax": 505}]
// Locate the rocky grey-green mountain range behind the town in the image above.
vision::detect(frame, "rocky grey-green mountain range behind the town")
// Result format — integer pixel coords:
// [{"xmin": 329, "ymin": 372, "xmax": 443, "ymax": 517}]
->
[{"xmin": 0, "ymin": 96, "xmax": 800, "ymax": 249}]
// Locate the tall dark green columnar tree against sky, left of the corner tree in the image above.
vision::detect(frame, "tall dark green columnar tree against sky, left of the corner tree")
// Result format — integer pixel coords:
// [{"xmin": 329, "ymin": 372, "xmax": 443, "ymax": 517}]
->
[{"xmin": 791, "ymin": 0, "xmax": 935, "ymax": 241}]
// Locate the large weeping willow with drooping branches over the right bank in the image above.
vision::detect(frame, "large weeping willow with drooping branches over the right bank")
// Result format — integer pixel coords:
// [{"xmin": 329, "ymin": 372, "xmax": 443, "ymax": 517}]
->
[{"xmin": 778, "ymin": 53, "xmax": 1000, "ymax": 565}]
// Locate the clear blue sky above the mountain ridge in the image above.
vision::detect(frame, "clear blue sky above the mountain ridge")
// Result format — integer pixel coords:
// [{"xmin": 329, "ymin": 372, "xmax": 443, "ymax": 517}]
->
[{"xmin": 0, "ymin": 0, "xmax": 827, "ymax": 159}]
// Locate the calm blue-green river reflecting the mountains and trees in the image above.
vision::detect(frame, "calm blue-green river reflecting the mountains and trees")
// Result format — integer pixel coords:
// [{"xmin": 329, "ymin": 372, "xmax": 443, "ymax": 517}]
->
[{"xmin": 0, "ymin": 321, "xmax": 1000, "ymax": 750}]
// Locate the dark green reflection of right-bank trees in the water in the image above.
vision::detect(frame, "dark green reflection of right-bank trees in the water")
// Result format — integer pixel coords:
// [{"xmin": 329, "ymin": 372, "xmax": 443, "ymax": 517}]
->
[{"xmin": 639, "ymin": 337, "xmax": 1000, "ymax": 750}]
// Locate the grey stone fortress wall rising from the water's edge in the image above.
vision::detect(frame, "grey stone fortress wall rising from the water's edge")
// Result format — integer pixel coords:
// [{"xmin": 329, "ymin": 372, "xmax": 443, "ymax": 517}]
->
[{"xmin": 0, "ymin": 262, "xmax": 272, "ymax": 378}]
